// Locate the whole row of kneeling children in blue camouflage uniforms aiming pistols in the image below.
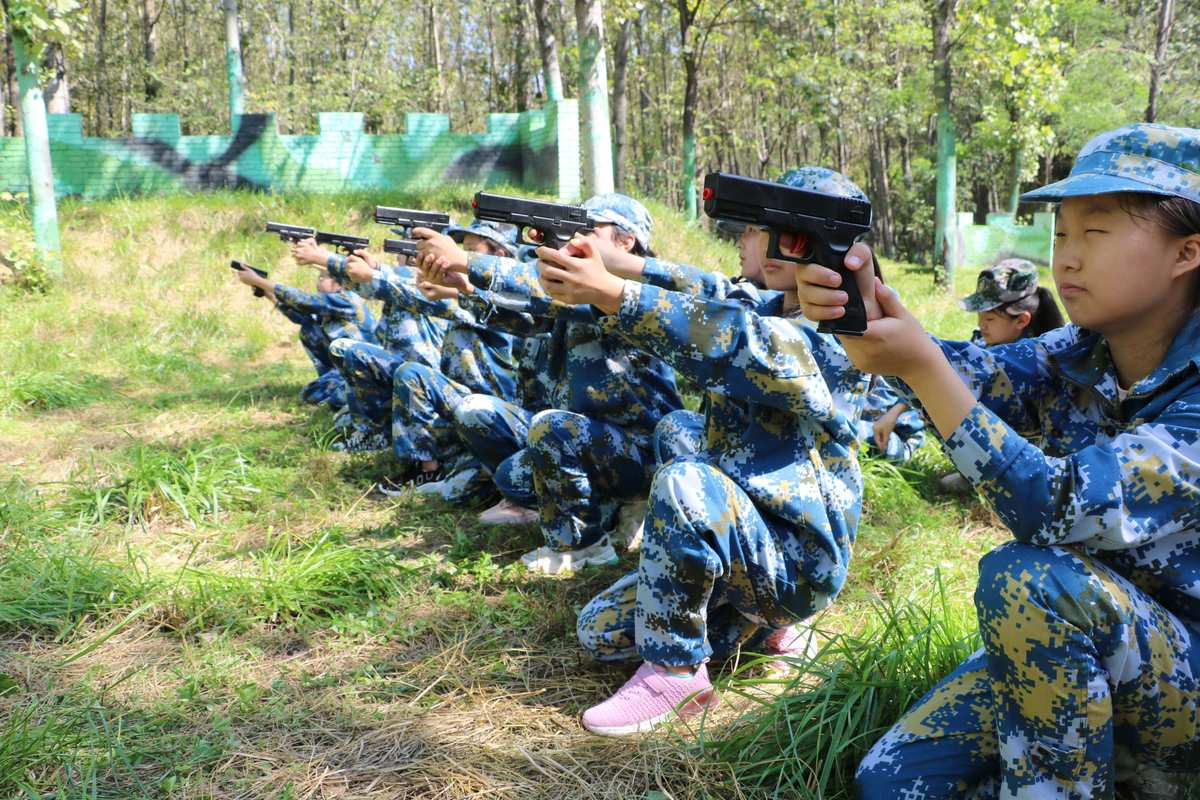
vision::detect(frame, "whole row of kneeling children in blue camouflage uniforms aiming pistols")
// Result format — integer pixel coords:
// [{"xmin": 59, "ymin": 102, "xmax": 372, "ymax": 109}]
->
[{"xmin": 231, "ymin": 124, "xmax": 1200, "ymax": 799}]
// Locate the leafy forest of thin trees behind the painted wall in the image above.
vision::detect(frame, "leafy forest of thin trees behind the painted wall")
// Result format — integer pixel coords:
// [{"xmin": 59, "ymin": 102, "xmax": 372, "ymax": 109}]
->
[{"xmin": 0, "ymin": 0, "xmax": 1200, "ymax": 264}]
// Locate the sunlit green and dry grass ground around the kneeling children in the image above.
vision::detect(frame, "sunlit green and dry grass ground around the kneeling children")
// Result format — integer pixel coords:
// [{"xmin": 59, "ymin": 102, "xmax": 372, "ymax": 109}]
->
[{"xmin": 0, "ymin": 187, "xmax": 1022, "ymax": 799}]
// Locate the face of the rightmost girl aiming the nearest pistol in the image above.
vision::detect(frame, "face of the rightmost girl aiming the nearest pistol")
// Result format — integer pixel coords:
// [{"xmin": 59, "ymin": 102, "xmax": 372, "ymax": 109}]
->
[{"xmin": 1054, "ymin": 194, "xmax": 1178, "ymax": 336}]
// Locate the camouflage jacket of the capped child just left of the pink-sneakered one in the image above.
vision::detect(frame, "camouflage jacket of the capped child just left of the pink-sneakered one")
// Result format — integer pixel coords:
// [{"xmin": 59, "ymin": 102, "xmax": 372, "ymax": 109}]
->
[{"xmin": 460, "ymin": 254, "xmax": 683, "ymax": 447}]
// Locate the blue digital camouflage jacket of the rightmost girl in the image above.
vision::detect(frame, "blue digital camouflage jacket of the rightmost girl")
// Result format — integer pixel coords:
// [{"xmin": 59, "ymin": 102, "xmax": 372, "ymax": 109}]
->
[{"xmin": 898, "ymin": 312, "xmax": 1200, "ymax": 630}]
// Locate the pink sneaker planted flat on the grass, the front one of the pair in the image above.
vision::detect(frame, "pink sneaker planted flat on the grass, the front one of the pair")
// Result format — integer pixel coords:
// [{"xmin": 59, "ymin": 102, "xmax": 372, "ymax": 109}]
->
[{"xmin": 583, "ymin": 662, "xmax": 716, "ymax": 736}]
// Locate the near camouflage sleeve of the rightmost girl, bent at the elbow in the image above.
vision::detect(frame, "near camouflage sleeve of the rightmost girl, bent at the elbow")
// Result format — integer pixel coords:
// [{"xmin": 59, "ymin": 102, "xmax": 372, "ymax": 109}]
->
[{"xmin": 946, "ymin": 391, "xmax": 1200, "ymax": 549}]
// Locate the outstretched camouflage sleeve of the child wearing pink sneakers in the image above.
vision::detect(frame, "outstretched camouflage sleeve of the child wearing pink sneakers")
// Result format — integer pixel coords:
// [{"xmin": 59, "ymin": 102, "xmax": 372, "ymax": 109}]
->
[{"xmin": 601, "ymin": 281, "xmax": 835, "ymax": 419}]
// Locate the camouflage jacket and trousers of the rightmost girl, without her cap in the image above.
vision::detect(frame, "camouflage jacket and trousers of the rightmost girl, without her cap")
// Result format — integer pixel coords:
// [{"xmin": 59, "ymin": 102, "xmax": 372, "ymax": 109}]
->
[{"xmin": 862, "ymin": 312, "xmax": 1200, "ymax": 798}]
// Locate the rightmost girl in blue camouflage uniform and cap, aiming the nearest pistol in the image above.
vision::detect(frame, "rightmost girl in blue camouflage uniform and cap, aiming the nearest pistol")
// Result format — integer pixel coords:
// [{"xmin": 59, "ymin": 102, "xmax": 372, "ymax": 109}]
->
[{"xmin": 799, "ymin": 125, "xmax": 1200, "ymax": 800}]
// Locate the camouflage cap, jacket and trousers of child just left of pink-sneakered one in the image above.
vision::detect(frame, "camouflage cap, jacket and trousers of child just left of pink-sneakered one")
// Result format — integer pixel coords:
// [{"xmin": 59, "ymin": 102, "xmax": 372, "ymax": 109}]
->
[{"xmin": 468, "ymin": 196, "xmax": 683, "ymax": 551}]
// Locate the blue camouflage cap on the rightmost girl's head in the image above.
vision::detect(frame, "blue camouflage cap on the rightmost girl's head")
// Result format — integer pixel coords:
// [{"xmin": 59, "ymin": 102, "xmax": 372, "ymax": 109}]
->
[{"xmin": 1021, "ymin": 122, "xmax": 1200, "ymax": 203}]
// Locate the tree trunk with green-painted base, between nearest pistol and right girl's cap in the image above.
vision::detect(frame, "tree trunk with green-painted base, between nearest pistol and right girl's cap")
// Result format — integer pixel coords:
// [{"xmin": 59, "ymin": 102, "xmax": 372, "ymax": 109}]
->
[{"xmin": 931, "ymin": 0, "xmax": 959, "ymax": 290}]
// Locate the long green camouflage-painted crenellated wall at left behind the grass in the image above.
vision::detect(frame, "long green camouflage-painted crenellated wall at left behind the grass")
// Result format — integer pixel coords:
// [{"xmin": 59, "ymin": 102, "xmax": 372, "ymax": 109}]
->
[{"xmin": 0, "ymin": 100, "xmax": 581, "ymax": 201}]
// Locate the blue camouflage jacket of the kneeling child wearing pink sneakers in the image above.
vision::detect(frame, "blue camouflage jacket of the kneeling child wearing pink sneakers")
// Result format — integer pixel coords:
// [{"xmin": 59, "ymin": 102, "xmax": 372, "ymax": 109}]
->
[{"xmin": 602, "ymin": 259, "xmax": 869, "ymax": 596}]
